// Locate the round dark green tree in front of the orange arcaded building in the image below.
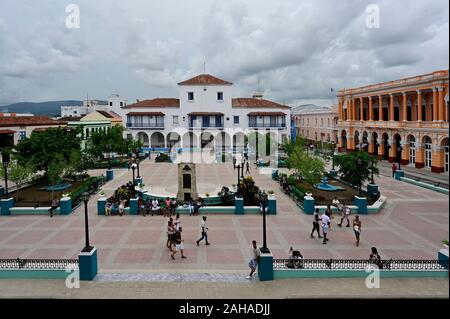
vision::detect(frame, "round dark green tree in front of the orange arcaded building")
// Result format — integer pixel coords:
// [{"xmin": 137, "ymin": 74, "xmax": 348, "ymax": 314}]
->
[{"xmin": 334, "ymin": 152, "xmax": 379, "ymax": 186}]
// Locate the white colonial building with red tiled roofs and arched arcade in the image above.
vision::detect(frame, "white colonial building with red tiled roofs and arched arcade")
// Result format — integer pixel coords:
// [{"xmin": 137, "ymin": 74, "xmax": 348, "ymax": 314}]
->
[{"xmin": 111, "ymin": 74, "xmax": 291, "ymax": 156}]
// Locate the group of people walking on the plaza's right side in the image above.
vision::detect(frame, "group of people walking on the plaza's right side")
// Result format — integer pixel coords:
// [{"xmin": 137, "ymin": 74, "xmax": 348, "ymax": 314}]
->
[{"xmin": 310, "ymin": 197, "xmax": 362, "ymax": 247}]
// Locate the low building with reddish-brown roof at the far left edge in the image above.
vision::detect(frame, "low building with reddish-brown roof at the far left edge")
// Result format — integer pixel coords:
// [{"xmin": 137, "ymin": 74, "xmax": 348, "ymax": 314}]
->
[{"xmin": 0, "ymin": 116, "xmax": 67, "ymax": 149}]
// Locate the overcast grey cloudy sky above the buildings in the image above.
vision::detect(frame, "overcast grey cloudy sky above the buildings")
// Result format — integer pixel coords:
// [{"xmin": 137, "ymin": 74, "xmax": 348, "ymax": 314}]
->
[{"xmin": 0, "ymin": 0, "xmax": 449, "ymax": 106}]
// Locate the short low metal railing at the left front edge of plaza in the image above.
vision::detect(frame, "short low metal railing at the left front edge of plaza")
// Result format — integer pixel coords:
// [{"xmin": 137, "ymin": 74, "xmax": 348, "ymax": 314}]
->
[{"xmin": 0, "ymin": 258, "xmax": 78, "ymax": 270}]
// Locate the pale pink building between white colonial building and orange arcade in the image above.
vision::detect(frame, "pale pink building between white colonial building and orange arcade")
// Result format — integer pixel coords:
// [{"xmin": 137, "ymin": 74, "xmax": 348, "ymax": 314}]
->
[{"xmin": 292, "ymin": 104, "xmax": 338, "ymax": 144}]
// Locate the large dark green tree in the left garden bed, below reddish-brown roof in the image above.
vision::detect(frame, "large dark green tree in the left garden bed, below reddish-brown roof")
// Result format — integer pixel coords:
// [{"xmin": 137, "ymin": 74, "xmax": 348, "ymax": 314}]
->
[{"xmin": 15, "ymin": 128, "xmax": 80, "ymax": 175}]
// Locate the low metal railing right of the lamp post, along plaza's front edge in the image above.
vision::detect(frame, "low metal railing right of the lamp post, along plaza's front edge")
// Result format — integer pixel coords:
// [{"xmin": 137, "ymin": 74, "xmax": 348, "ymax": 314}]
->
[{"xmin": 273, "ymin": 259, "xmax": 449, "ymax": 270}]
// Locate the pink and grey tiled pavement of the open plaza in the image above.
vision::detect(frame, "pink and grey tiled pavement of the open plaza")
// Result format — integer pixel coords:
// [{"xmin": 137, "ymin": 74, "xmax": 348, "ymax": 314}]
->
[{"xmin": 0, "ymin": 161, "xmax": 449, "ymax": 274}]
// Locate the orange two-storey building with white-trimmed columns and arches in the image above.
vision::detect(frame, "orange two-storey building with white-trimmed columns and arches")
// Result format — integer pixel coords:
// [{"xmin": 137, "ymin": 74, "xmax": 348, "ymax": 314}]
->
[{"xmin": 338, "ymin": 70, "xmax": 449, "ymax": 173}]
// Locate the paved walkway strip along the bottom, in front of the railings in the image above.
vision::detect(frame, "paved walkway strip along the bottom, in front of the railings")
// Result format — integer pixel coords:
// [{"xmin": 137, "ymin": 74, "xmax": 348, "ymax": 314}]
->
[{"xmin": 0, "ymin": 278, "xmax": 449, "ymax": 299}]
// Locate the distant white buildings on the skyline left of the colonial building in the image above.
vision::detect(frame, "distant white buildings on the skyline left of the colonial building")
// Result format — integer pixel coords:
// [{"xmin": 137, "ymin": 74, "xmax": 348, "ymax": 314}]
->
[{"xmin": 61, "ymin": 94, "xmax": 127, "ymax": 118}]
